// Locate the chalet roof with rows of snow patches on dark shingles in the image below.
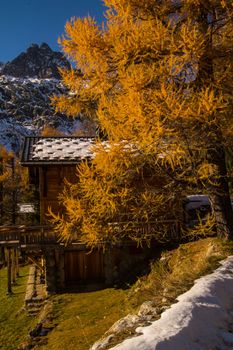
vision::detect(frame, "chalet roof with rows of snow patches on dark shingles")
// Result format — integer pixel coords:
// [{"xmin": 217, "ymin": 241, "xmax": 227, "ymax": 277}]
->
[{"xmin": 21, "ymin": 136, "xmax": 94, "ymax": 166}]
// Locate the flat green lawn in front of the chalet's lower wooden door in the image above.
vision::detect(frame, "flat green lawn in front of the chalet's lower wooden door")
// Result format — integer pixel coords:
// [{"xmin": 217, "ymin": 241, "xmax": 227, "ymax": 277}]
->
[{"xmin": 40, "ymin": 288, "xmax": 127, "ymax": 350}]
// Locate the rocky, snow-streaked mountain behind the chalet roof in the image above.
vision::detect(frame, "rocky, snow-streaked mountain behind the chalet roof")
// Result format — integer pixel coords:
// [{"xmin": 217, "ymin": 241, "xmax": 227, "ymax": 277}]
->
[{"xmin": 0, "ymin": 44, "xmax": 80, "ymax": 153}]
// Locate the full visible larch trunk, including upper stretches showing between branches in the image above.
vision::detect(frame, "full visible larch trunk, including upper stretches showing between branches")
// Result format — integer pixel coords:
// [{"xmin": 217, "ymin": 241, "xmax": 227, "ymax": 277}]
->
[{"xmin": 195, "ymin": 6, "xmax": 233, "ymax": 240}]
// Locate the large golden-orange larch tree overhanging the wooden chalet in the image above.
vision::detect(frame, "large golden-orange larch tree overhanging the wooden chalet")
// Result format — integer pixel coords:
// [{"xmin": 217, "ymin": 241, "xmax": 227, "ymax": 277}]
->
[{"xmin": 54, "ymin": 0, "xmax": 233, "ymax": 245}]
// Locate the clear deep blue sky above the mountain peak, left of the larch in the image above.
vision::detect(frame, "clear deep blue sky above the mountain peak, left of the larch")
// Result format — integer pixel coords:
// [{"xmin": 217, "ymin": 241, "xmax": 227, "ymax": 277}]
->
[{"xmin": 0, "ymin": 0, "xmax": 104, "ymax": 62}]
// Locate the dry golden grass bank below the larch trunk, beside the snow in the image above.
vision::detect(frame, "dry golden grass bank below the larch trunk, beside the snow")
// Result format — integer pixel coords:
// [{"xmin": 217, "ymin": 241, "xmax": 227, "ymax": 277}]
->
[{"xmin": 129, "ymin": 238, "xmax": 233, "ymax": 308}]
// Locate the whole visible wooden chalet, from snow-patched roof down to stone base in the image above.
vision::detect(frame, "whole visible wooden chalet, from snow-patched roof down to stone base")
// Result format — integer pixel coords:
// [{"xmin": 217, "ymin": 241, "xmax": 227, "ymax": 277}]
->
[{"xmin": 17, "ymin": 137, "xmax": 149, "ymax": 293}]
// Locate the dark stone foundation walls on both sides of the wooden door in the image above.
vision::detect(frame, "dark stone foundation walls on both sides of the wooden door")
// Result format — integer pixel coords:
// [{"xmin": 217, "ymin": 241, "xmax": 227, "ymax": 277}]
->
[{"xmin": 44, "ymin": 244, "xmax": 154, "ymax": 294}]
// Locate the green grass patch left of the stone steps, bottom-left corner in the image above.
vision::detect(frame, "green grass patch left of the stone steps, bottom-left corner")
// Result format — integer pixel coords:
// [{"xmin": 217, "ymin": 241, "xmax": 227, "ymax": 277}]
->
[{"xmin": 0, "ymin": 266, "xmax": 35, "ymax": 350}]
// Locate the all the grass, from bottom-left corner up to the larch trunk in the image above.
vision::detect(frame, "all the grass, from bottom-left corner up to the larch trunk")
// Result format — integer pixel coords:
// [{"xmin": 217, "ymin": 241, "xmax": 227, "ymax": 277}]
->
[{"xmin": 0, "ymin": 238, "xmax": 233, "ymax": 350}]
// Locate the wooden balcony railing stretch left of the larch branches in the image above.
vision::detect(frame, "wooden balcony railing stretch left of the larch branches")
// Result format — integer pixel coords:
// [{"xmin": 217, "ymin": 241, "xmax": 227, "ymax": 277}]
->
[{"xmin": 0, "ymin": 225, "xmax": 58, "ymax": 246}]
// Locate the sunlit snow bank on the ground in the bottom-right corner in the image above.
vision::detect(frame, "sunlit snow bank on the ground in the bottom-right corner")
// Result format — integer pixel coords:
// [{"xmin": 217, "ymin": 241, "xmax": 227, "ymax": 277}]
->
[{"xmin": 111, "ymin": 256, "xmax": 233, "ymax": 350}]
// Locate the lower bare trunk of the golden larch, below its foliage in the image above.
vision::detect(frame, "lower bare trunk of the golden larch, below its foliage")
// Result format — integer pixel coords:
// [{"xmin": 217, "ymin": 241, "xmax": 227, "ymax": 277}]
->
[{"xmin": 207, "ymin": 146, "xmax": 233, "ymax": 240}]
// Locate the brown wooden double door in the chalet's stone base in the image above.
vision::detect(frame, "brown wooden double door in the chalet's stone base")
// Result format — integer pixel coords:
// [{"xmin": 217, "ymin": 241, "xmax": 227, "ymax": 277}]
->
[{"xmin": 65, "ymin": 250, "xmax": 104, "ymax": 284}]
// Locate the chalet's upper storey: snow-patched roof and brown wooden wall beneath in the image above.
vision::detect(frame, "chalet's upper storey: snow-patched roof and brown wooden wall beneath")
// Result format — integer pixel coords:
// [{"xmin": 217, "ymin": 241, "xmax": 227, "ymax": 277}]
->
[{"xmin": 21, "ymin": 137, "xmax": 93, "ymax": 225}]
